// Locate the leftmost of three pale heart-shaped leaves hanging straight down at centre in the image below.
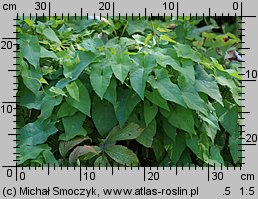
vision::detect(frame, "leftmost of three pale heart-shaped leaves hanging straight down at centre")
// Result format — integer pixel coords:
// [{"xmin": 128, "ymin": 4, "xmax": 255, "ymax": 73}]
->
[{"xmin": 90, "ymin": 60, "xmax": 112, "ymax": 99}]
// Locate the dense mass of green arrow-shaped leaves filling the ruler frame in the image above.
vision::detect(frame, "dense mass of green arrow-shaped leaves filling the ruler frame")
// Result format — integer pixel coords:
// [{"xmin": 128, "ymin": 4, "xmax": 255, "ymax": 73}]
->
[{"xmin": 17, "ymin": 17, "xmax": 241, "ymax": 166}]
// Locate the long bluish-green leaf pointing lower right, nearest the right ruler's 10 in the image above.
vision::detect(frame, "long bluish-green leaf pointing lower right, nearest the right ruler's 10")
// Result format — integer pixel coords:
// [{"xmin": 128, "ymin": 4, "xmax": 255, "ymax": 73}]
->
[{"xmin": 195, "ymin": 65, "xmax": 223, "ymax": 106}]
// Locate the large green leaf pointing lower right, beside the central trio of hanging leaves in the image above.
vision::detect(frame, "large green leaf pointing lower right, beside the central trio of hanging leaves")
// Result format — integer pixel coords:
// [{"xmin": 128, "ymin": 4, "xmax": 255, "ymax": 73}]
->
[{"xmin": 148, "ymin": 69, "xmax": 185, "ymax": 106}]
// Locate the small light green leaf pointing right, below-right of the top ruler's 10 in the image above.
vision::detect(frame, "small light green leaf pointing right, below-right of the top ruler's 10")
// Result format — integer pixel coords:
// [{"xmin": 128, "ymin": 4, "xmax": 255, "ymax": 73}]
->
[{"xmin": 173, "ymin": 43, "xmax": 201, "ymax": 62}]
